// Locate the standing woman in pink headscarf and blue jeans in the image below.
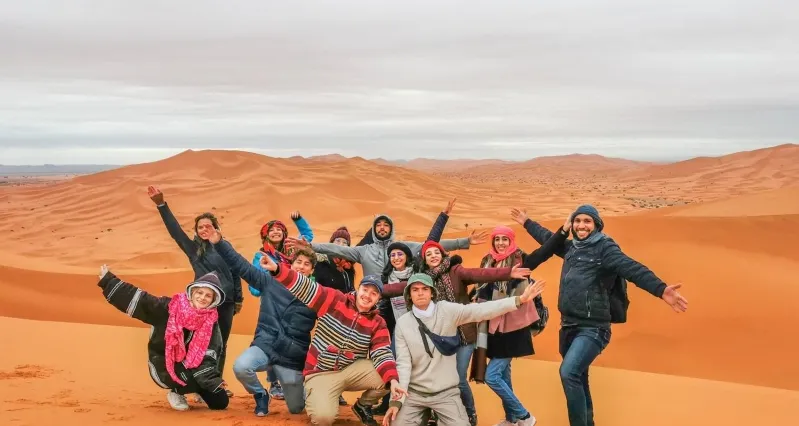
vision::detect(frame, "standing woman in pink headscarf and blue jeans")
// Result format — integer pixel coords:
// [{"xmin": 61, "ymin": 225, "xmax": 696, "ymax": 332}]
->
[{"xmin": 472, "ymin": 219, "xmax": 571, "ymax": 426}]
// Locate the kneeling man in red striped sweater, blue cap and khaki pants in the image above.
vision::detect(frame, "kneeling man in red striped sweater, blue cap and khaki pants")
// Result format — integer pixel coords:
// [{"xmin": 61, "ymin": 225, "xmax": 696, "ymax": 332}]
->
[{"xmin": 261, "ymin": 251, "xmax": 405, "ymax": 426}]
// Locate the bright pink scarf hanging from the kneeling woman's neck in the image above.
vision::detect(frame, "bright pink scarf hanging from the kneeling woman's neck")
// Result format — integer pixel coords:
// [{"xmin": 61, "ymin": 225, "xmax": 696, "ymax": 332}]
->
[{"xmin": 164, "ymin": 293, "xmax": 219, "ymax": 386}]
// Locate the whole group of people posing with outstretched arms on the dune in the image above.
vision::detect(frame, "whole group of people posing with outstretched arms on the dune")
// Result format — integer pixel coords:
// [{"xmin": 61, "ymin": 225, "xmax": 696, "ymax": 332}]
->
[{"xmin": 98, "ymin": 187, "xmax": 687, "ymax": 426}]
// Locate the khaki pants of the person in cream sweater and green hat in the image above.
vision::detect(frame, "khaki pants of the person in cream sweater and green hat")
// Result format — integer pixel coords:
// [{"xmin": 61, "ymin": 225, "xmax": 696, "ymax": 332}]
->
[{"xmin": 391, "ymin": 388, "xmax": 469, "ymax": 426}]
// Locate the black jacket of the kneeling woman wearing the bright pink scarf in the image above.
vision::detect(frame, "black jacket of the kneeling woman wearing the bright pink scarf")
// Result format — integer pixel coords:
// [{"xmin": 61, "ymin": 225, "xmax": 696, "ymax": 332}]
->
[{"xmin": 97, "ymin": 272, "xmax": 225, "ymax": 393}]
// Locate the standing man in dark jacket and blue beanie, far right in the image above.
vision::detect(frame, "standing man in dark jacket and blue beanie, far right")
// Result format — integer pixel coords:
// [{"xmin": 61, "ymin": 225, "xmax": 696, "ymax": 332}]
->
[{"xmin": 511, "ymin": 204, "xmax": 688, "ymax": 426}]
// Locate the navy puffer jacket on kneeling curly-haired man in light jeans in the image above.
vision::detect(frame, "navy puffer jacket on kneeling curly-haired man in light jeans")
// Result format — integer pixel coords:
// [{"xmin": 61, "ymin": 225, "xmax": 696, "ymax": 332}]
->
[{"xmin": 214, "ymin": 240, "xmax": 316, "ymax": 371}]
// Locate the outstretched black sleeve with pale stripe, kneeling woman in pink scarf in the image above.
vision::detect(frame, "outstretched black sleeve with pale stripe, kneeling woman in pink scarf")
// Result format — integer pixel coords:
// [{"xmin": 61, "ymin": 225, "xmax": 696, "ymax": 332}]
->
[{"xmin": 97, "ymin": 265, "xmax": 171, "ymax": 325}]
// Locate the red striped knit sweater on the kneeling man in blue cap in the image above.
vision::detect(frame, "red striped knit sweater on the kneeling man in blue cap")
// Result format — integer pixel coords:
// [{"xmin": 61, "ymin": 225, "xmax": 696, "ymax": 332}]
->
[{"xmin": 275, "ymin": 265, "xmax": 399, "ymax": 383}]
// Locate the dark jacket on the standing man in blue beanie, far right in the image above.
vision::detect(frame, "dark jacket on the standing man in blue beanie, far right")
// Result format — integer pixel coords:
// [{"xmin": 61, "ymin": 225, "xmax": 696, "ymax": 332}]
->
[{"xmin": 524, "ymin": 219, "xmax": 666, "ymax": 327}]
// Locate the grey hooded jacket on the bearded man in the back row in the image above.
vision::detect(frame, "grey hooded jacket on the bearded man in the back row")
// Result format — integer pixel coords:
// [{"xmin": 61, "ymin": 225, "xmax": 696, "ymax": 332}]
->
[{"xmin": 311, "ymin": 214, "xmax": 470, "ymax": 276}]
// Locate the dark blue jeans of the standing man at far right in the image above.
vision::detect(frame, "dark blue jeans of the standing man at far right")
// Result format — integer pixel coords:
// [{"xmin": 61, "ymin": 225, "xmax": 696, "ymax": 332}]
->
[{"xmin": 559, "ymin": 326, "xmax": 610, "ymax": 426}]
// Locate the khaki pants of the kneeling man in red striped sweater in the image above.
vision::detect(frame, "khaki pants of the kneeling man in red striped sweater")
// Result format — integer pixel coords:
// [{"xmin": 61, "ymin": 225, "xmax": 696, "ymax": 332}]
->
[{"xmin": 305, "ymin": 359, "xmax": 390, "ymax": 426}]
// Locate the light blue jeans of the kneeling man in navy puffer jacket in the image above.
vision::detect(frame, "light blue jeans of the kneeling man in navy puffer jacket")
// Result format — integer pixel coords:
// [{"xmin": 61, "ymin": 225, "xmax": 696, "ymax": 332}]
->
[{"xmin": 233, "ymin": 346, "xmax": 305, "ymax": 414}]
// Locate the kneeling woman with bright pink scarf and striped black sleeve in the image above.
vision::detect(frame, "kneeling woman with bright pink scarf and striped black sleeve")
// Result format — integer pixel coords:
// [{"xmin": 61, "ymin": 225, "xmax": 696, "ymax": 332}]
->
[{"xmin": 97, "ymin": 265, "xmax": 229, "ymax": 411}]
